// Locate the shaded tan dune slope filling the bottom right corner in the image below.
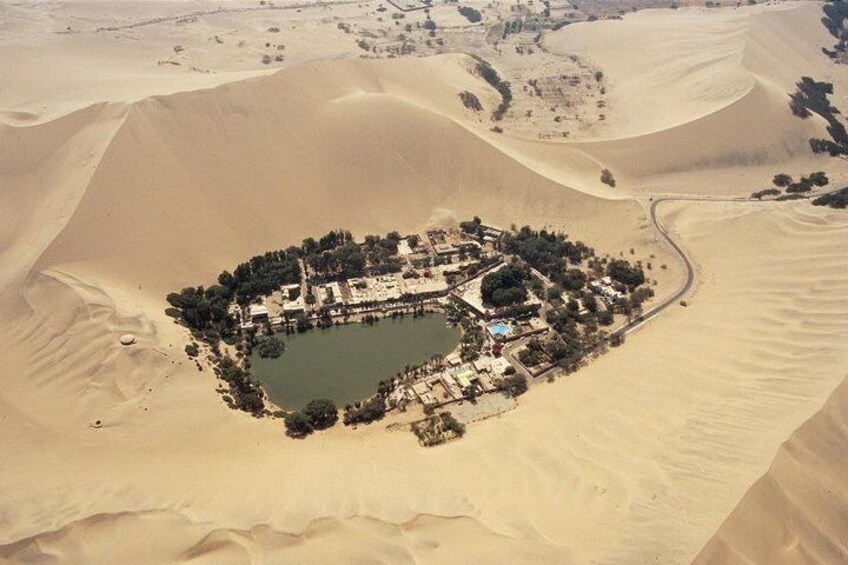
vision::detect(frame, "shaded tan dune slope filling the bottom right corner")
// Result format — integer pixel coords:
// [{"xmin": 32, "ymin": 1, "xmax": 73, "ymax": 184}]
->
[{"xmin": 695, "ymin": 374, "xmax": 848, "ymax": 563}]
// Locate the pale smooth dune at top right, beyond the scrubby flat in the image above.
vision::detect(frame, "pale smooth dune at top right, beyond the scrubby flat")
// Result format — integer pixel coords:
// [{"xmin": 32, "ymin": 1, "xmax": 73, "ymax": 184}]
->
[{"xmin": 545, "ymin": 3, "xmax": 832, "ymax": 139}]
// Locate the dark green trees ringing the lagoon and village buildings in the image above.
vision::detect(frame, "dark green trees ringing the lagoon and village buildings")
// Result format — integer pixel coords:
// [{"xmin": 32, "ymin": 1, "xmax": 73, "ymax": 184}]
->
[{"xmin": 166, "ymin": 216, "xmax": 653, "ymax": 438}]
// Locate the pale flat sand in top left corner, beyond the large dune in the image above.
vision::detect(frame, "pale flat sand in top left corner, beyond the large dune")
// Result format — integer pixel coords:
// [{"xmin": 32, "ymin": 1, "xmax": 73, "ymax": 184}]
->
[{"xmin": 0, "ymin": 0, "xmax": 268, "ymax": 125}]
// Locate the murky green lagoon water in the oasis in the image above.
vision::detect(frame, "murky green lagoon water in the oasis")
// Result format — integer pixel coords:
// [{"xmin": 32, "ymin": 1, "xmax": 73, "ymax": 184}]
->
[{"xmin": 251, "ymin": 314, "xmax": 459, "ymax": 409}]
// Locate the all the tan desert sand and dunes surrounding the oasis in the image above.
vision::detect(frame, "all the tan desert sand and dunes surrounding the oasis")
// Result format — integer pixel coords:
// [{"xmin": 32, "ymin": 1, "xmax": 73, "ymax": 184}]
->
[{"xmin": 0, "ymin": 1, "xmax": 848, "ymax": 563}]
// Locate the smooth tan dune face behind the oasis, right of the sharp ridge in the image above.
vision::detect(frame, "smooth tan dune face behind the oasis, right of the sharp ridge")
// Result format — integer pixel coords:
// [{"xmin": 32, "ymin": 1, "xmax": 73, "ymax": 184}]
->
[{"xmin": 31, "ymin": 56, "xmax": 624, "ymax": 298}]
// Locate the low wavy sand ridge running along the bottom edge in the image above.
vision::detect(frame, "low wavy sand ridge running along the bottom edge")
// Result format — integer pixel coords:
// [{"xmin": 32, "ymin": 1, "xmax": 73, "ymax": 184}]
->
[{"xmin": 0, "ymin": 512, "xmax": 567, "ymax": 564}]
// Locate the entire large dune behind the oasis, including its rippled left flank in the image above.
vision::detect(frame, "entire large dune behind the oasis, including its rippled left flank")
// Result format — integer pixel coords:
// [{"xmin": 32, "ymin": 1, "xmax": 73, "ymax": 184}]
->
[{"xmin": 0, "ymin": 51, "xmax": 640, "ymax": 446}]
